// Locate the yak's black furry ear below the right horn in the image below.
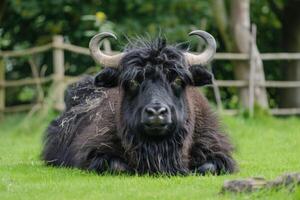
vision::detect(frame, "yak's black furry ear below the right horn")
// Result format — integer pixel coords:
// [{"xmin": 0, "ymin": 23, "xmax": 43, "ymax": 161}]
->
[{"xmin": 189, "ymin": 65, "xmax": 213, "ymax": 86}]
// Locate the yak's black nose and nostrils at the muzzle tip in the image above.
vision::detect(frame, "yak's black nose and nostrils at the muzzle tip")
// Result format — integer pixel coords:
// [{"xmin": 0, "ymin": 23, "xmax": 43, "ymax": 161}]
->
[{"xmin": 143, "ymin": 104, "xmax": 171, "ymax": 127}]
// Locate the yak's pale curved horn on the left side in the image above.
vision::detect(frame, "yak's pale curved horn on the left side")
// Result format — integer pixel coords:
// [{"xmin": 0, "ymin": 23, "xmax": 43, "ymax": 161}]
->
[{"xmin": 89, "ymin": 32, "xmax": 123, "ymax": 67}]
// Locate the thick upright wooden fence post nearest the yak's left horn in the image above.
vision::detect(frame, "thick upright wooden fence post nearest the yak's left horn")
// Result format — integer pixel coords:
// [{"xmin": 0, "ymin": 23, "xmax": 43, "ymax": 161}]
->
[{"xmin": 53, "ymin": 35, "xmax": 65, "ymax": 111}]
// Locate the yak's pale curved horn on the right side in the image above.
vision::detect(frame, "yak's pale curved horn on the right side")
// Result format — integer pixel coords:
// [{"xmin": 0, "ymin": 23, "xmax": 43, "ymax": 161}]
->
[{"xmin": 184, "ymin": 30, "xmax": 217, "ymax": 65}]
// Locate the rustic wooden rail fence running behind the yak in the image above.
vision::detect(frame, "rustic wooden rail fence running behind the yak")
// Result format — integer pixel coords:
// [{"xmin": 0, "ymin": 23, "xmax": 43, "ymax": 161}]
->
[{"xmin": 0, "ymin": 36, "xmax": 300, "ymax": 115}]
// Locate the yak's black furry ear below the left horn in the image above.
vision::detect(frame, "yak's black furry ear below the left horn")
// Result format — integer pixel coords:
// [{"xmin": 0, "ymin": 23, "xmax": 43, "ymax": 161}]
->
[{"xmin": 94, "ymin": 67, "xmax": 120, "ymax": 87}]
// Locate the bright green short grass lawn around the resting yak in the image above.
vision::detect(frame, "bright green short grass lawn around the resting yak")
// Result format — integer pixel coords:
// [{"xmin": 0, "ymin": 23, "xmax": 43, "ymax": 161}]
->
[{"xmin": 0, "ymin": 113, "xmax": 300, "ymax": 200}]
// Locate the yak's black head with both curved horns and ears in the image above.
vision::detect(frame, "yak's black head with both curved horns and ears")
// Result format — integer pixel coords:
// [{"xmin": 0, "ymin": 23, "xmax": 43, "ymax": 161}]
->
[{"xmin": 90, "ymin": 31, "xmax": 216, "ymax": 139}]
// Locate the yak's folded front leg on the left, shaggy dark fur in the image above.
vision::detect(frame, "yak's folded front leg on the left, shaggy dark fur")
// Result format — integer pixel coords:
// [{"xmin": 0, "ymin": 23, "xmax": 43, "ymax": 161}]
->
[{"xmin": 71, "ymin": 128, "xmax": 130, "ymax": 173}]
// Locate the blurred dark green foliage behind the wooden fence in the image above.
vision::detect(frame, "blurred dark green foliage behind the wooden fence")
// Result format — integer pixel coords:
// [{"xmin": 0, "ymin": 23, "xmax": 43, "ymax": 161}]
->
[{"xmin": 0, "ymin": 0, "xmax": 293, "ymax": 108}]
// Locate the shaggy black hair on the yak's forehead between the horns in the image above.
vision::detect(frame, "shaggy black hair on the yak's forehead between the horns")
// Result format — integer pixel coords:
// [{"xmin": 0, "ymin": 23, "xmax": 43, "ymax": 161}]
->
[{"xmin": 121, "ymin": 37, "xmax": 191, "ymax": 82}]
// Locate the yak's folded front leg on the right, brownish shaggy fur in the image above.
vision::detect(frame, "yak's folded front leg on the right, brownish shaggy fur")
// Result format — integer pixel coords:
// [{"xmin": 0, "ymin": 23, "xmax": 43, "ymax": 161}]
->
[{"xmin": 190, "ymin": 110, "xmax": 236, "ymax": 175}]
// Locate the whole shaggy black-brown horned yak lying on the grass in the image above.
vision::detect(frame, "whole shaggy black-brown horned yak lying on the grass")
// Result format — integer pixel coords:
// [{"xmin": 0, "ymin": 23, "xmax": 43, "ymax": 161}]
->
[{"xmin": 42, "ymin": 30, "xmax": 237, "ymax": 175}]
